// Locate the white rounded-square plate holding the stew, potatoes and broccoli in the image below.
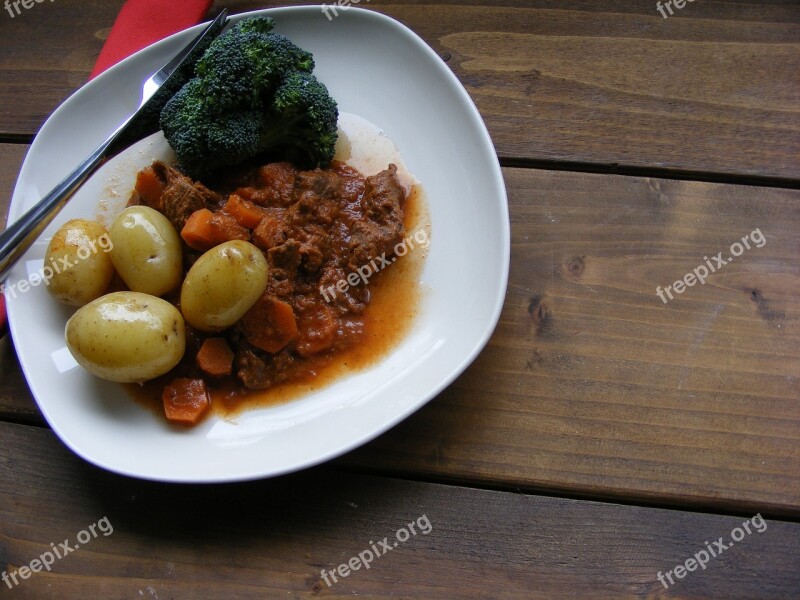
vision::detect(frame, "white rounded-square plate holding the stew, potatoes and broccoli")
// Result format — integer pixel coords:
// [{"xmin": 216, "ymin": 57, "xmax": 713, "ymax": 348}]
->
[{"xmin": 7, "ymin": 6, "xmax": 509, "ymax": 482}]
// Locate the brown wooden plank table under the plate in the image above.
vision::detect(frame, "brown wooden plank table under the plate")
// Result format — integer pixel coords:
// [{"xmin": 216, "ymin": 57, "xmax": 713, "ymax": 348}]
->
[{"xmin": 0, "ymin": 0, "xmax": 800, "ymax": 599}]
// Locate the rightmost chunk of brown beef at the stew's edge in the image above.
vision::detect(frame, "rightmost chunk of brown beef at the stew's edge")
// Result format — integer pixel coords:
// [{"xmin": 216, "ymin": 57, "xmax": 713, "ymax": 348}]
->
[{"xmin": 347, "ymin": 165, "xmax": 406, "ymax": 271}]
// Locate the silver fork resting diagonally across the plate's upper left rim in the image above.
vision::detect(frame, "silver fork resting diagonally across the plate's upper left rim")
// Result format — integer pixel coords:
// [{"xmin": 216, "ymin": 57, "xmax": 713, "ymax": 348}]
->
[{"xmin": 0, "ymin": 9, "xmax": 228, "ymax": 282}]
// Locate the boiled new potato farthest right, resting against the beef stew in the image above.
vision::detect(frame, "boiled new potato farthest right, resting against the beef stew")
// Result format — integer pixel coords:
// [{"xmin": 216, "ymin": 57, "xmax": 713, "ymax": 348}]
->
[{"xmin": 181, "ymin": 240, "xmax": 269, "ymax": 331}]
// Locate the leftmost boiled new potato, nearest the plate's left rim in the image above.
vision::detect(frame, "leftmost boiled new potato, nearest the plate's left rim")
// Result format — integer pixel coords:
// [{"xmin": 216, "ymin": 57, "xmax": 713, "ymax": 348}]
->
[{"xmin": 42, "ymin": 219, "xmax": 114, "ymax": 306}]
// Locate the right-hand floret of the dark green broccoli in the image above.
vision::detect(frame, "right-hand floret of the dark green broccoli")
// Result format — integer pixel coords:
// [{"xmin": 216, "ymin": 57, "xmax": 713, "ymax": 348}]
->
[{"xmin": 261, "ymin": 71, "xmax": 339, "ymax": 167}]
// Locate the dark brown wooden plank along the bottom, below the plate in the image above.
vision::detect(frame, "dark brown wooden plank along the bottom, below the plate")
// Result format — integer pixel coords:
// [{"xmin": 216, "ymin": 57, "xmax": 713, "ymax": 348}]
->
[{"xmin": 0, "ymin": 423, "xmax": 800, "ymax": 599}]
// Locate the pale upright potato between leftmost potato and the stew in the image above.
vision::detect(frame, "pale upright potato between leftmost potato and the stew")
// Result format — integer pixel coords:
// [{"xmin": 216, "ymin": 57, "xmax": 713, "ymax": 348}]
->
[{"xmin": 108, "ymin": 206, "xmax": 183, "ymax": 296}]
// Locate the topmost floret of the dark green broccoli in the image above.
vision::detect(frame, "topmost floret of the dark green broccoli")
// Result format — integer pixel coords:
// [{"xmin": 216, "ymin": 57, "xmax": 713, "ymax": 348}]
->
[{"xmin": 196, "ymin": 17, "xmax": 314, "ymax": 111}]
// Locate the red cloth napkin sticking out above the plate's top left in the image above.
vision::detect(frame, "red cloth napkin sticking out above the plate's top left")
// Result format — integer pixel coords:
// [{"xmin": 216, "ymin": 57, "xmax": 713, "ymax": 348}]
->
[{"xmin": 89, "ymin": 0, "xmax": 212, "ymax": 79}]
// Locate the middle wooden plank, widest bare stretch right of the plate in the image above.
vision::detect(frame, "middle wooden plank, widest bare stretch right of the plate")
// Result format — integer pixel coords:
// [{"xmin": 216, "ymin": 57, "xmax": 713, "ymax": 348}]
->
[{"xmin": 0, "ymin": 156, "xmax": 800, "ymax": 514}]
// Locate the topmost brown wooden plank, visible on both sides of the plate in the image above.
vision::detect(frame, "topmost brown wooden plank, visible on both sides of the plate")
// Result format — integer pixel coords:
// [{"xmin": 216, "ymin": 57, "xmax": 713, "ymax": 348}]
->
[{"xmin": 0, "ymin": 0, "xmax": 800, "ymax": 179}]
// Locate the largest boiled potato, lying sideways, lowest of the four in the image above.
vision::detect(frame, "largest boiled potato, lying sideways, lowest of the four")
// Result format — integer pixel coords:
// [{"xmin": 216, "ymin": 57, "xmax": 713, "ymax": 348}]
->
[{"xmin": 65, "ymin": 292, "xmax": 186, "ymax": 383}]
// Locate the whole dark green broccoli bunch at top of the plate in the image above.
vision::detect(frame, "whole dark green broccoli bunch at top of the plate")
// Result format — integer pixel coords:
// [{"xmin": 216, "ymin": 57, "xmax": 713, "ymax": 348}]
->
[{"xmin": 160, "ymin": 17, "xmax": 338, "ymax": 177}]
